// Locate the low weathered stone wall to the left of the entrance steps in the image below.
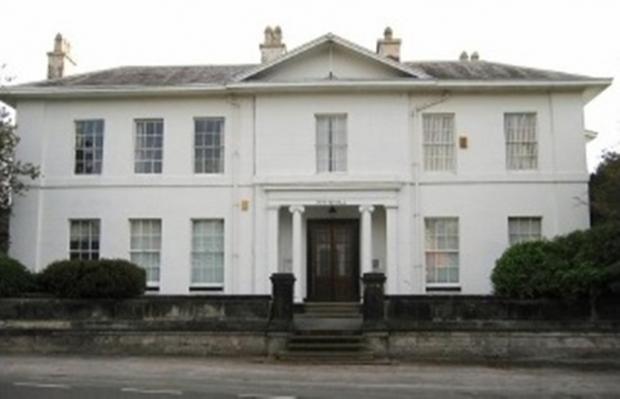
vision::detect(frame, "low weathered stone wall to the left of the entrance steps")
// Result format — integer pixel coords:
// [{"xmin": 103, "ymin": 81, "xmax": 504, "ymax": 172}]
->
[{"xmin": 0, "ymin": 296, "xmax": 271, "ymax": 356}]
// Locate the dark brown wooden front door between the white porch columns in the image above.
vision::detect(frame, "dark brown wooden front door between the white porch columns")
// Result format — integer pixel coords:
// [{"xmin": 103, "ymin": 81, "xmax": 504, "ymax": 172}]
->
[{"xmin": 307, "ymin": 219, "xmax": 359, "ymax": 302}]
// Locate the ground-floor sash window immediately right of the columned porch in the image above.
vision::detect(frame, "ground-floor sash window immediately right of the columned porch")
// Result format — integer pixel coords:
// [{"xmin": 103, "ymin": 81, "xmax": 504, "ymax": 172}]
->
[{"xmin": 424, "ymin": 217, "xmax": 459, "ymax": 284}]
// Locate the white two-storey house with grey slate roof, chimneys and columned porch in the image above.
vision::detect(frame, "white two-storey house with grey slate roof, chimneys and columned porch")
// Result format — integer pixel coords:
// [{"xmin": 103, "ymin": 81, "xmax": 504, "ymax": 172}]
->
[{"xmin": 1, "ymin": 28, "xmax": 611, "ymax": 300}]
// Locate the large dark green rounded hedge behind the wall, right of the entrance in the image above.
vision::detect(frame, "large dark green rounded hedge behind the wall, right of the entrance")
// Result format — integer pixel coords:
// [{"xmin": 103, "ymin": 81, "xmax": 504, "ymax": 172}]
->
[{"xmin": 491, "ymin": 224, "xmax": 620, "ymax": 299}]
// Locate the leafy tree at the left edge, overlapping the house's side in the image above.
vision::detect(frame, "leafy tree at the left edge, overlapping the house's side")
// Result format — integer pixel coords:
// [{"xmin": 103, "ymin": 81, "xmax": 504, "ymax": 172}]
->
[{"xmin": 0, "ymin": 67, "xmax": 40, "ymax": 252}]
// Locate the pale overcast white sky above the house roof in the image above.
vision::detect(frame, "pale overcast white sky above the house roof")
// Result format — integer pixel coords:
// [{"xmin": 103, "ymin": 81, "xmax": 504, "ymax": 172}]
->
[{"xmin": 0, "ymin": 0, "xmax": 620, "ymax": 170}]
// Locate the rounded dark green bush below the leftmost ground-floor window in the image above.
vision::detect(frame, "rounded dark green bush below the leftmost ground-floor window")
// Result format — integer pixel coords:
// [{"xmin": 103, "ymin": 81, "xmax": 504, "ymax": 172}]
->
[{"xmin": 39, "ymin": 259, "xmax": 146, "ymax": 299}]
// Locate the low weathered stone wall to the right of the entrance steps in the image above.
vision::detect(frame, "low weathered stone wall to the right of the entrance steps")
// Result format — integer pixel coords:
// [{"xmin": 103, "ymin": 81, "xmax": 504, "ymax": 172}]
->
[{"xmin": 369, "ymin": 295, "xmax": 620, "ymax": 366}]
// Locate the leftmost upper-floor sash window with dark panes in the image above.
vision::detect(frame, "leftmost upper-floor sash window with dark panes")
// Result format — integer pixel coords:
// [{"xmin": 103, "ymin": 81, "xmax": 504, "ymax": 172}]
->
[{"xmin": 74, "ymin": 119, "xmax": 103, "ymax": 175}]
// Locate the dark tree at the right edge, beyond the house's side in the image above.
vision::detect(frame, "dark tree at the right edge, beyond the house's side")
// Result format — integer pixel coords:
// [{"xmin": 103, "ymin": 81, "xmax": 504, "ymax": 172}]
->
[{"xmin": 589, "ymin": 151, "xmax": 620, "ymax": 226}]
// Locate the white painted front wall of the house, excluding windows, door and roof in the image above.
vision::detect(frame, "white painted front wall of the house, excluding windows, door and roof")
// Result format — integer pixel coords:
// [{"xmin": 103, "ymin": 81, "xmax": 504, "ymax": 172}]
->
[{"xmin": 2, "ymin": 32, "xmax": 608, "ymax": 300}]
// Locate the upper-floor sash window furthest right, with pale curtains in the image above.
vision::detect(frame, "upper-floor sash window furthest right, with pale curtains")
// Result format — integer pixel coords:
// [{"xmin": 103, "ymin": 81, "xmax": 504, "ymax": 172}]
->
[{"xmin": 504, "ymin": 112, "xmax": 538, "ymax": 170}]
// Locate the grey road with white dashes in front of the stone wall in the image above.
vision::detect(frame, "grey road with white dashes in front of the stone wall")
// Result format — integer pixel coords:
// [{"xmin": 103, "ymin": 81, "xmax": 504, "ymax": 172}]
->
[{"xmin": 0, "ymin": 355, "xmax": 620, "ymax": 399}]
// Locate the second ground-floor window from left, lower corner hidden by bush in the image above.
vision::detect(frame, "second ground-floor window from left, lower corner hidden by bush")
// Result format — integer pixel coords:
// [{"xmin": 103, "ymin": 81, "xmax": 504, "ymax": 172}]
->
[{"xmin": 130, "ymin": 219, "xmax": 161, "ymax": 286}]
